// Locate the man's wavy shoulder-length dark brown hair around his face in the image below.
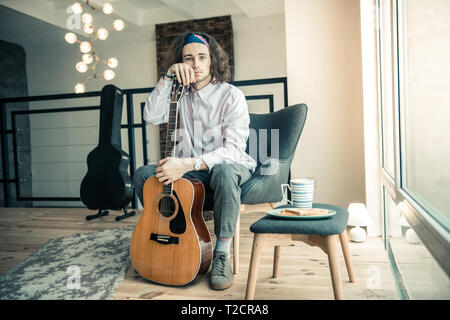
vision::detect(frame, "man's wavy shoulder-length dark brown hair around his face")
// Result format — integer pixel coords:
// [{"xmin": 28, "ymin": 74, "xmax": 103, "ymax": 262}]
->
[{"xmin": 162, "ymin": 31, "xmax": 231, "ymax": 82}]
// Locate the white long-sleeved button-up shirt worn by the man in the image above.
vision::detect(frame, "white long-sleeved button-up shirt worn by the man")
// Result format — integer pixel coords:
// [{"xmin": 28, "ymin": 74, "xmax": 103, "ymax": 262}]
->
[{"xmin": 144, "ymin": 78, "xmax": 256, "ymax": 173}]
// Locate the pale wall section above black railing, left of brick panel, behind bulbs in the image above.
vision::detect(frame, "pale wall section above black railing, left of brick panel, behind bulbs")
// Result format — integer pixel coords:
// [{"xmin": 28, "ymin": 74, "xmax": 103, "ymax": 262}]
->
[{"xmin": 25, "ymin": 41, "xmax": 156, "ymax": 95}]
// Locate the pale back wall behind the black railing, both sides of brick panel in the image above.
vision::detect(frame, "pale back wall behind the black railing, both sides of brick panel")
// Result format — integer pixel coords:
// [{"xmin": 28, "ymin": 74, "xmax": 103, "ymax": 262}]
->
[{"xmin": 24, "ymin": 15, "xmax": 286, "ymax": 206}]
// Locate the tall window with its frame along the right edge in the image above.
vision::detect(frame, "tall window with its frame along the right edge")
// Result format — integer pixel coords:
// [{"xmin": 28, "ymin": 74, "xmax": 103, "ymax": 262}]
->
[{"xmin": 377, "ymin": 0, "xmax": 450, "ymax": 299}]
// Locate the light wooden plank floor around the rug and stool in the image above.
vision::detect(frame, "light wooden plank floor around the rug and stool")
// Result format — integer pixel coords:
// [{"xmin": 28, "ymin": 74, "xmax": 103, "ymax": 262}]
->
[{"xmin": 0, "ymin": 205, "xmax": 398, "ymax": 300}]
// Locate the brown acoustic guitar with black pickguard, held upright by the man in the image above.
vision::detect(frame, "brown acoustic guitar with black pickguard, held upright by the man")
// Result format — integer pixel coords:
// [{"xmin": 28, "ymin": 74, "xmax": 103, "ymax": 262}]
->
[{"xmin": 130, "ymin": 80, "xmax": 212, "ymax": 285}]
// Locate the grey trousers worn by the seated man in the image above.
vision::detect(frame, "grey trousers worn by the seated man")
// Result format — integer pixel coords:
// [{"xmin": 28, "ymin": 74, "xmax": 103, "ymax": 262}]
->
[{"xmin": 133, "ymin": 164, "xmax": 252, "ymax": 238}]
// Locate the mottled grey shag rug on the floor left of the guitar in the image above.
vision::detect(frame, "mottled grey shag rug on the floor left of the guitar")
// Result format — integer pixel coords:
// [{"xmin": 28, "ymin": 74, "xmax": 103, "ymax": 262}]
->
[{"xmin": 0, "ymin": 226, "xmax": 134, "ymax": 300}]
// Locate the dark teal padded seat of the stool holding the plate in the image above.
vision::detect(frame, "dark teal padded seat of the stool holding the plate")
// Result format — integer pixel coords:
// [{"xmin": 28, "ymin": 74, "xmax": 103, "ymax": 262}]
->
[{"xmin": 250, "ymin": 203, "xmax": 348, "ymax": 235}]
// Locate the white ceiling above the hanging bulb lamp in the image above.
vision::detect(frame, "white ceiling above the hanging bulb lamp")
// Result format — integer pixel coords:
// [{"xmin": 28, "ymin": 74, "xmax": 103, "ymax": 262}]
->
[{"xmin": 0, "ymin": 0, "xmax": 284, "ymax": 45}]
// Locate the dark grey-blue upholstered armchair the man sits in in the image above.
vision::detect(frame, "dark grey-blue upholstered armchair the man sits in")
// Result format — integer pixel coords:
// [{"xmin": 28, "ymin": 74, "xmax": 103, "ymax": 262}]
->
[{"xmin": 203, "ymin": 104, "xmax": 308, "ymax": 273}]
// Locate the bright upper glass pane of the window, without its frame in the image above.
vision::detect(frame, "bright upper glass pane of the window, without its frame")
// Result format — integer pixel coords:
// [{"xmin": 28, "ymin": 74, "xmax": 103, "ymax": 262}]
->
[{"xmin": 399, "ymin": 0, "xmax": 450, "ymax": 230}]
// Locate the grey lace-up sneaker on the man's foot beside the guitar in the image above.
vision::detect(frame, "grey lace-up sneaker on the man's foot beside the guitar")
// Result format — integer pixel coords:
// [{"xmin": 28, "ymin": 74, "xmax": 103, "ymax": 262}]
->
[{"xmin": 210, "ymin": 251, "xmax": 233, "ymax": 290}]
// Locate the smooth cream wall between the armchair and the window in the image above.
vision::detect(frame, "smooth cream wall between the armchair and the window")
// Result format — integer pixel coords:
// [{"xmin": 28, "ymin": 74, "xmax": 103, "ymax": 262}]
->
[{"xmin": 285, "ymin": 0, "xmax": 365, "ymax": 207}]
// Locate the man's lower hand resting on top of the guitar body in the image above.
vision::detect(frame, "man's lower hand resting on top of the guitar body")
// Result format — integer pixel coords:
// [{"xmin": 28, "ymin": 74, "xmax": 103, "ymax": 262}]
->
[{"xmin": 156, "ymin": 157, "xmax": 193, "ymax": 185}]
